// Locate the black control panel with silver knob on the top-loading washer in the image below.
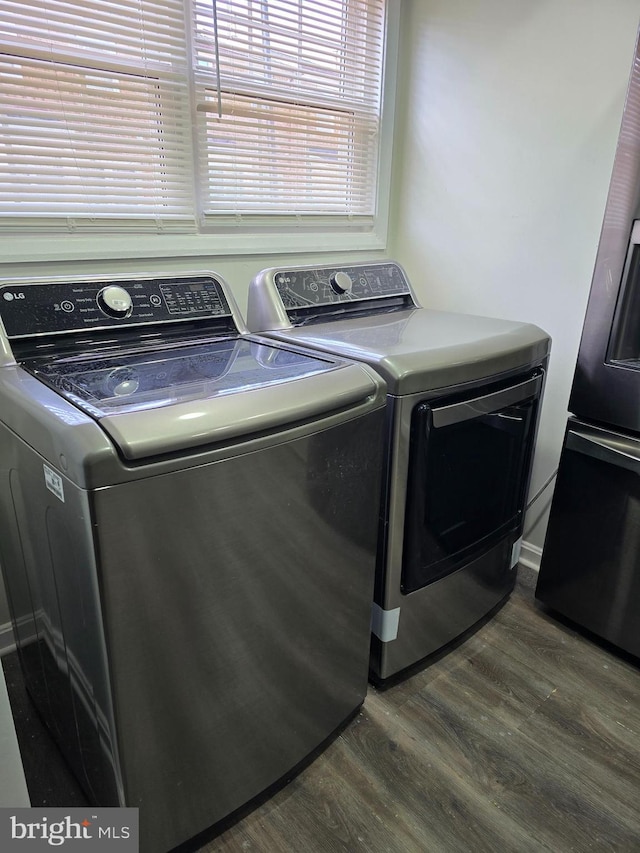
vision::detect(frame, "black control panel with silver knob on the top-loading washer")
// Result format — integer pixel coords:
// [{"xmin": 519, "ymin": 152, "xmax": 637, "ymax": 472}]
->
[{"xmin": 0, "ymin": 276, "xmax": 232, "ymax": 338}]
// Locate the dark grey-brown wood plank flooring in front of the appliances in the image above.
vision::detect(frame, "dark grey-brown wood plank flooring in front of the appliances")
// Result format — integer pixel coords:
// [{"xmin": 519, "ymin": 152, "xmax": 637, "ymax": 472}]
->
[{"xmin": 197, "ymin": 569, "xmax": 640, "ymax": 853}]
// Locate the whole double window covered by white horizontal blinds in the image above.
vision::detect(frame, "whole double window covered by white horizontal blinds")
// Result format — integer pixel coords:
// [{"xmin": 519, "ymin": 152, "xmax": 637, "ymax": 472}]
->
[{"xmin": 0, "ymin": 0, "xmax": 385, "ymax": 245}]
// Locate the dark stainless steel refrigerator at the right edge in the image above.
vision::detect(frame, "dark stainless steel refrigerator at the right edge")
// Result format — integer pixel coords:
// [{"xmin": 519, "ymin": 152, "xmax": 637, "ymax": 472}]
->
[{"xmin": 536, "ymin": 26, "xmax": 640, "ymax": 656}]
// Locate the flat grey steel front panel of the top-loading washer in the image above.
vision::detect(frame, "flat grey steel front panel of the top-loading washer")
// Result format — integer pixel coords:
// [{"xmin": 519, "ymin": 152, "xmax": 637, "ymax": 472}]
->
[{"xmin": 94, "ymin": 412, "xmax": 381, "ymax": 849}]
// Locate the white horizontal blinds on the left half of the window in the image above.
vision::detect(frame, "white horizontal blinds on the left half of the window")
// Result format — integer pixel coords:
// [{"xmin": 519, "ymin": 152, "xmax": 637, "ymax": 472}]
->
[{"xmin": 0, "ymin": 0, "xmax": 193, "ymax": 229}]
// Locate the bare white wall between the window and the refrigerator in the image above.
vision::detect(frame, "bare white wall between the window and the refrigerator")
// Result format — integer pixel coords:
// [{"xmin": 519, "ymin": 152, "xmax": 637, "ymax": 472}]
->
[{"xmin": 389, "ymin": 0, "xmax": 640, "ymax": 558}]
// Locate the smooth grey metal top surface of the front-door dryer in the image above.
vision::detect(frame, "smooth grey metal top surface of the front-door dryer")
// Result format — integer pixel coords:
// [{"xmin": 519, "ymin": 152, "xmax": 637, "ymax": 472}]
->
[{"xmin": 260, "ymin": 308, "xmax": 550, "ymax": 395}]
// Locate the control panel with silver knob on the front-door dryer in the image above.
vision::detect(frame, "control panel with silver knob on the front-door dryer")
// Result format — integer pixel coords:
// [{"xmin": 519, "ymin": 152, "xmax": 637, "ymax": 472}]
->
[{"xmin": 274, "ymin": 263, "xmax": 411, "ymax": 311}]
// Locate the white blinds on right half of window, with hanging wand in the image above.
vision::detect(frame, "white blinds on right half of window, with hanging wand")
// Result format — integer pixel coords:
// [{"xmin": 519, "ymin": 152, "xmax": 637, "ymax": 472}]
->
[{"xmin": 193, "ymin": 0, "xmax": 384, "ymax": 217}]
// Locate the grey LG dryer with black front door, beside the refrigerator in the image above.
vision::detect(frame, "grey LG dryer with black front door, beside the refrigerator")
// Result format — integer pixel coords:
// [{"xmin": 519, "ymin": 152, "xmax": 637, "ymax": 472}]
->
[{"xmin": 247, "ymin": 261, "xmax": 550, "ymax": 682}]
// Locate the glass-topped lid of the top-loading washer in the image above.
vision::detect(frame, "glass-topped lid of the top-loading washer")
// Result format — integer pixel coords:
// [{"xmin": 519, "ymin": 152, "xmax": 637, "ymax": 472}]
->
[{"xmin": 23, "ymin": 338, "xmax": 381, "ymax": 459}]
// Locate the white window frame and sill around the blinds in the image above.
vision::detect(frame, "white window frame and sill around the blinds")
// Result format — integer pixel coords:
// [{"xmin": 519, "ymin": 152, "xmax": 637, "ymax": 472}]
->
[{"xmin": 0, "ymin": 0, "xmax": 400, "ymax": 264}]
